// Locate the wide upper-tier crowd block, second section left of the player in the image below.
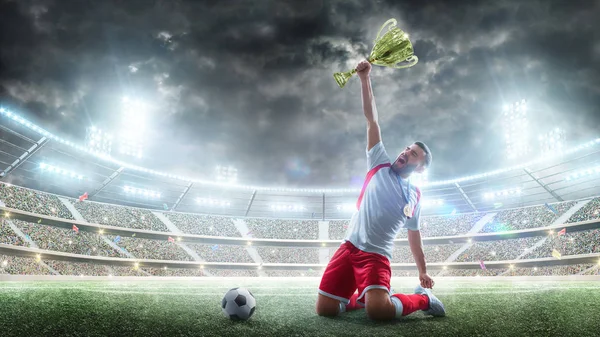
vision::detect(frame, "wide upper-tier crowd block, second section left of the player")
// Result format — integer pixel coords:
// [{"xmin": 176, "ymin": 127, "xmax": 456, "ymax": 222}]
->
[{"xmin": 244, "ymin": 218, "xmax": 319, "ymax": 240}]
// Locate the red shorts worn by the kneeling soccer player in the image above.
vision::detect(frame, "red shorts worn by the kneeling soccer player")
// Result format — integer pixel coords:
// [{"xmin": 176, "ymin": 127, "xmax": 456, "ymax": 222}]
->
[{"xmin": 319, "ymin": 241, "xmax": 392, "ymax": 305}]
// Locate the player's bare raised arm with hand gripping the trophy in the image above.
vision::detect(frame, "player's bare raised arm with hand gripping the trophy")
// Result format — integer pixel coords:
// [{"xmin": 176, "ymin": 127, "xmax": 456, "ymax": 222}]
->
[{"xmin": 356, "ymin": 61, "xmax": 381, "ymax": 150}]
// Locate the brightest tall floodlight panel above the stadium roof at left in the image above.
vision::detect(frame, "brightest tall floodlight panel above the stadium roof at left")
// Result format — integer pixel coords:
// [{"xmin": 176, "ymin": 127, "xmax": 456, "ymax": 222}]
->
[{"xmin": 119, "ymin": 97, "xmax": 147, "ymax": 158}]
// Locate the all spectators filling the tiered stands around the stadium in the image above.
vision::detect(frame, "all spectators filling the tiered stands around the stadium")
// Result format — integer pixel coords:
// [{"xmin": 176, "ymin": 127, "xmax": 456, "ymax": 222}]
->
[{"xmin": 0, "ymin": 183, "xmax": 600, "ymax": 276}]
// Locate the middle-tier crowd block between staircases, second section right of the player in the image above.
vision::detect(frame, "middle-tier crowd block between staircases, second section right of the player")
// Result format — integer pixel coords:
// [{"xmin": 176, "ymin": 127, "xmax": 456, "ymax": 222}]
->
[{"xmin": 456, "ymin": 237, "xmax": 543, "ymax": 262}]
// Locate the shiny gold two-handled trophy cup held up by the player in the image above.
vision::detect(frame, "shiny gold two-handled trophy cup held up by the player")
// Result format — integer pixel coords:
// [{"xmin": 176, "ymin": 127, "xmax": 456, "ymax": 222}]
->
[{"xmin": 333, "ymin": 19, "xmax": 419, "ymax": 88}]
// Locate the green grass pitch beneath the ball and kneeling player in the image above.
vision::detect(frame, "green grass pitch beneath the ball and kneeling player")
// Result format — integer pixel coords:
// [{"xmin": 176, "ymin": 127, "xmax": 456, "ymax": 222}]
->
[{"xmin": 0, "ymin": 278, "xmax": 600, "ymax": 337}]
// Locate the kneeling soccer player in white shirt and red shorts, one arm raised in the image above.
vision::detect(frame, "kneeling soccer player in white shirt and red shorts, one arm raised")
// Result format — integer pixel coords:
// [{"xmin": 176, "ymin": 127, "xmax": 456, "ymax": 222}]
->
[{"xmin": 316, "ymin": 61, "xmax": 445, "ymax": 320}]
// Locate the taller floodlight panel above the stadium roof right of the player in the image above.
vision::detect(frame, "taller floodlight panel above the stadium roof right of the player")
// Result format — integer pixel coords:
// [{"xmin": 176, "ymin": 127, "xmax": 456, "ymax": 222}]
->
[{"xmin": 502, "ymin": 99, "xmax": 531, "ymax": 159}]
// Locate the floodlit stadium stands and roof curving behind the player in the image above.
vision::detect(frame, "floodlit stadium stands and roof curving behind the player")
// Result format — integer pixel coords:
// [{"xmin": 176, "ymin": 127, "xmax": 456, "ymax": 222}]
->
[{"xmin": 0, "ymin": 105, "xmax": 600, "ymax": 334}]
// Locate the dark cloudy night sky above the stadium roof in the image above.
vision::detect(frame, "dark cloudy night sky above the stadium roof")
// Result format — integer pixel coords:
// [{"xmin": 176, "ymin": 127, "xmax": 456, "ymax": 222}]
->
[{"xmin": 0, "ymin": 0, "xmax": 600, "ymax": 188}]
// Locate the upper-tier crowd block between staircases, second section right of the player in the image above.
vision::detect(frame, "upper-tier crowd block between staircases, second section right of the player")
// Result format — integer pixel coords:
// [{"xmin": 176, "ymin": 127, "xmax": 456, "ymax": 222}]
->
[{"xmin": 480, "ymin": 201, "xmax": 575, "ymax": 233}]
